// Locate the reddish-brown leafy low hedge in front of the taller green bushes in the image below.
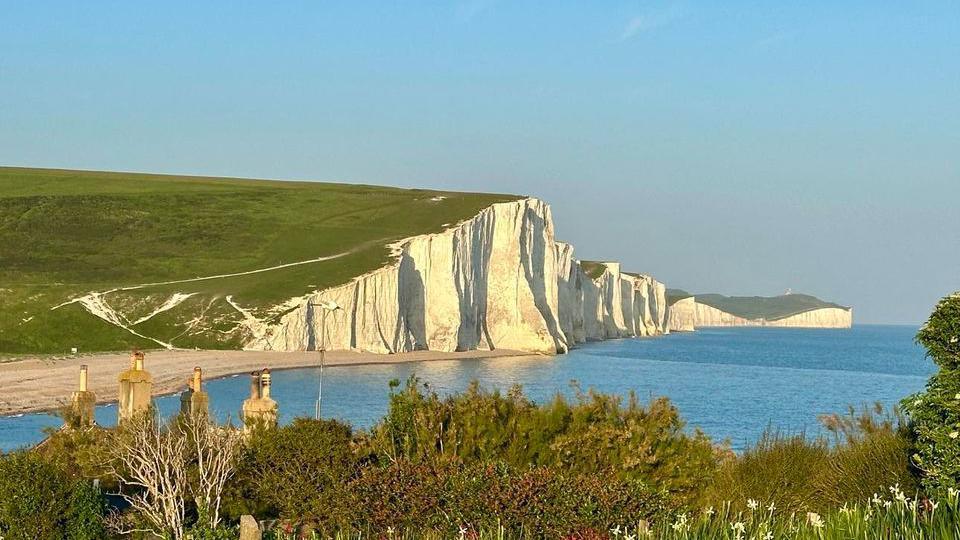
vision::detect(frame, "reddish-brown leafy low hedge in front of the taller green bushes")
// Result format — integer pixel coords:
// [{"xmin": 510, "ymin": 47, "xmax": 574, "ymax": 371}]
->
[{"xmin": 351, "ymin": 460, "xmax": 665, "ymax": 537}]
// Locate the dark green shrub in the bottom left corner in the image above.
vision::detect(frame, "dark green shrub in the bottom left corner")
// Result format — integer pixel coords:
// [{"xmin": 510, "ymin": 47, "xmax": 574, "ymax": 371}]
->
[{"xmin": 0, "ymin": 452, "xmax": 105, "ymax": 540}]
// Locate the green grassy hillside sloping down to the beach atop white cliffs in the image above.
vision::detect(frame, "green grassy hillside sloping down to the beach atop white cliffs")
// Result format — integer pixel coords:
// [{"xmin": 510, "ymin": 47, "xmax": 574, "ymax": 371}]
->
[{"xmin": 0, "ymin": 168, "xmax": 517, "ymax": 354}]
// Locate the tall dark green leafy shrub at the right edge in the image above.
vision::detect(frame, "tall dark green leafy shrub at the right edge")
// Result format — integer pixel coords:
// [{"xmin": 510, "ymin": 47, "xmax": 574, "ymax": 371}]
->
[{"xmin": 902, "ymin": 293, "xmax": 960, "ymax": 493}]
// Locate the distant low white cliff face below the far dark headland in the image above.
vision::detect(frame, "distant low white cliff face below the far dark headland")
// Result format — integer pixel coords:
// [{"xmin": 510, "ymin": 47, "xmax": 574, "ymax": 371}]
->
[{"xmin": 670, "ymin": 296, "xmax": 853, "ymax": 332}]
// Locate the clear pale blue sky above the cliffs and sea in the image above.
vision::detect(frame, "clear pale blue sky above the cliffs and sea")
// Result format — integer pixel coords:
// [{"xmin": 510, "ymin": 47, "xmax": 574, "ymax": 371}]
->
[{"xmin": 0, "ymin": 0, "xmax": 960, "ymax": 323}]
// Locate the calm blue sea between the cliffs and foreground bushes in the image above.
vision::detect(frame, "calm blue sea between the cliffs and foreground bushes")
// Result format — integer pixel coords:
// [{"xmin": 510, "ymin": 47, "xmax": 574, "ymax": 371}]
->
[{"xmin": 0, "ymin": 326, "xmax": 934, "ymax": 450}]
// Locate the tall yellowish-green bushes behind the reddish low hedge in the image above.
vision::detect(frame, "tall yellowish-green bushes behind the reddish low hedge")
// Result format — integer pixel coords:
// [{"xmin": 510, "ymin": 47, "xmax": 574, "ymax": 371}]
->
[{"xmin": 368, "ymin": 378, "xmax": 718, "ymax": 501}]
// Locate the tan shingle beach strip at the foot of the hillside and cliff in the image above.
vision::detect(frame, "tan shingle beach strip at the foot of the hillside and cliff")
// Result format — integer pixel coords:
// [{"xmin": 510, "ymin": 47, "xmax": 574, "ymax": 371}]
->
[{"xmin": 0, "ymin": 349, "xmax": 530, "ymax": 416}]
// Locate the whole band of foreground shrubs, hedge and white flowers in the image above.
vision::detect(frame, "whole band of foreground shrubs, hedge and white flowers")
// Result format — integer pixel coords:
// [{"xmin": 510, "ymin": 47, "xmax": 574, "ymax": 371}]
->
[{"xmin": 0, "ymin": 296, "xmax": 960, "ymax": 540}]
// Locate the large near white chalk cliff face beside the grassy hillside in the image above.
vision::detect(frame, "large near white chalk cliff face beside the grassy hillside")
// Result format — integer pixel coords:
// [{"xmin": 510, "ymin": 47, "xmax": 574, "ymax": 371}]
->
[{"xmin": 246, "ymin": 199, "xmax": 667, "ymax": 354}]
